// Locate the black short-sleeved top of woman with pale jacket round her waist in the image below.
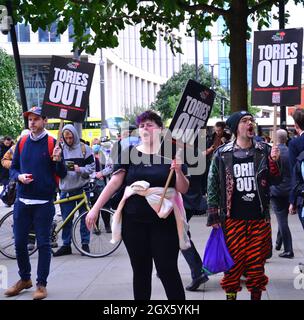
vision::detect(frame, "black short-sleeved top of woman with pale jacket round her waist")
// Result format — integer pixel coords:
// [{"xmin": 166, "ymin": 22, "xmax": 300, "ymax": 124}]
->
[{"xmin": 114, "ymin": 147, "xmax": 186, "ymax": 222}]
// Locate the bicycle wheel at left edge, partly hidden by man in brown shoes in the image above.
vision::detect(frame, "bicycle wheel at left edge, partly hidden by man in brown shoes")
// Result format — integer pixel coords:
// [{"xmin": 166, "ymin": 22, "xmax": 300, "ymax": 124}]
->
[{"xmin": 0, "ymin": 211, "xmax": 37, "ymax": 259}]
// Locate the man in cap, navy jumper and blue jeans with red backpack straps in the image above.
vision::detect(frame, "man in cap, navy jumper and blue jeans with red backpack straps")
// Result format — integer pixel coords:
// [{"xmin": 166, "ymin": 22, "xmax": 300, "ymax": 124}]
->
[{"xmin": 4, "ymin": 107, "xmax": 66, "ymax": 300}]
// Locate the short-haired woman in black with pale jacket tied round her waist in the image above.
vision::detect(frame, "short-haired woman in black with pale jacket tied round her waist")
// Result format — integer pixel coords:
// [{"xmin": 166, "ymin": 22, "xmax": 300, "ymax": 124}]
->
[{"xmin": 86, "ymin": 110, "xmax": 189, "ymax": 300}]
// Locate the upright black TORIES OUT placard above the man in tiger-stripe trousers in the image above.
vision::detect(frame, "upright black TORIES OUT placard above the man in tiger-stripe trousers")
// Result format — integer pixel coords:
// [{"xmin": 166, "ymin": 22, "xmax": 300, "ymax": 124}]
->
[{"xmin": 252, "ymin": 28, "xmax": 303, "ymax": 106}]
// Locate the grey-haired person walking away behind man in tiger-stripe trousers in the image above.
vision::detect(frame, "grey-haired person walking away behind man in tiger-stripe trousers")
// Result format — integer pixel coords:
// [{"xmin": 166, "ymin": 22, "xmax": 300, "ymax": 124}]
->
[{"xmin": 270, "ymin": 129, "xmax": 294, "ymax": 258}]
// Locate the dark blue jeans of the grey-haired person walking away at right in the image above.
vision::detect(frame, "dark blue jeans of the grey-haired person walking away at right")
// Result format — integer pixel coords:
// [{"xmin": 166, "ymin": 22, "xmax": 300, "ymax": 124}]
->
[{"xmin": 271, "ymin": 197, "xmax": 293, "ymax": 252}]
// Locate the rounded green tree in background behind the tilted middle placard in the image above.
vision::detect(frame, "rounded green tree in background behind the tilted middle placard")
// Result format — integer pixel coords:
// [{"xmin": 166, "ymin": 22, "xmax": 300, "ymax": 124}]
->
[{"xmin": 152, "ymin": 64, "xmax": 229, "ymax": 120}]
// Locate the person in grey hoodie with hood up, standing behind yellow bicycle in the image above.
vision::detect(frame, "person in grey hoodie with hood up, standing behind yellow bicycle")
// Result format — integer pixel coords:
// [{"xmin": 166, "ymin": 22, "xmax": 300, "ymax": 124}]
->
[{"xmin": 53, "ymin": 124, "xmax": 95, "ymax": 257}]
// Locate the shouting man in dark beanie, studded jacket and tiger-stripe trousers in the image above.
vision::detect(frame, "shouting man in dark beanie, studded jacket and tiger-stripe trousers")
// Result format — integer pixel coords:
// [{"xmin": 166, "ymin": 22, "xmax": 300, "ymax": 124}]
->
[{"xmin": 207, "ymin": 111, "xmax": 281, "ymax": 300}]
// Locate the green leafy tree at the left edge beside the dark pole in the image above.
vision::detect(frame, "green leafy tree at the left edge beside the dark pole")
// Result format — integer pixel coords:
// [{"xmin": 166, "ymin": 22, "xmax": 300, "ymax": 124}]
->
[{"xmin": 0, "ymin": 49, "xmax": 23, "ymax": 138}]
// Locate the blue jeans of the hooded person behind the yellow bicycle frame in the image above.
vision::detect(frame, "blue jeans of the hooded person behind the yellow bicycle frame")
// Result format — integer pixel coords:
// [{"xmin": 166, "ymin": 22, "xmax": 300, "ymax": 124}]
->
[{"xmin": 60, "ymin": 188, "xmax": 90, "ymax": 246}]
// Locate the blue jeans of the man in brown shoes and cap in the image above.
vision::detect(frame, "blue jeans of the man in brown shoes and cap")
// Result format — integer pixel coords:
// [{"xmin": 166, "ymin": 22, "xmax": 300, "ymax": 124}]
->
[{"xmin": 14, "ymin": 199, "xmax": 55, "ymax": 286}]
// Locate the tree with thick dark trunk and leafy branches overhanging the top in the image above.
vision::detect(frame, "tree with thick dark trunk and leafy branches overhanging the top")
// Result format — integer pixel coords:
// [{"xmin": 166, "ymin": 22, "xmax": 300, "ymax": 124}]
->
[{"xmin": 0, "ymin": 0, "xmax": 304, "ymax": 111}]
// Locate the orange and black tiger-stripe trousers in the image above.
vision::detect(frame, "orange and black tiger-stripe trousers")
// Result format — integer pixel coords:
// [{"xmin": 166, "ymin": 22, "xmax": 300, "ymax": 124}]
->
[{"xmin": 221, "ymin": 218, "xmax": 271, "ymax": 292}]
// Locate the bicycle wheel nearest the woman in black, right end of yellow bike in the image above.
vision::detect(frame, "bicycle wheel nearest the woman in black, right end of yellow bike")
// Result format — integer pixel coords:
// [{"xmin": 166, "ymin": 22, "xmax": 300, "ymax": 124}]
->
[{"xmin": 72, "ymin": 209, "xmax": 121, "ymax": 258}]
